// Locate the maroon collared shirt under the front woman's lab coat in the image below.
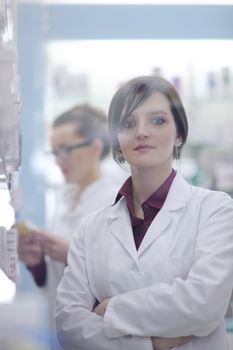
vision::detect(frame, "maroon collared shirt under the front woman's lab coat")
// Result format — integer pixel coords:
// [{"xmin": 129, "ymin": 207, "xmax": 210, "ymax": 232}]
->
[{"xmin": 115, "ymin": 169, "xmax": 176, "ymax": 249}]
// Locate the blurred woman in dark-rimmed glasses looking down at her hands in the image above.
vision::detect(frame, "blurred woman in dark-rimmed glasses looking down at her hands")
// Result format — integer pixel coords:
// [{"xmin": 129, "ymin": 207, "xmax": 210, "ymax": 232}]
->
[{"xmin": 19, "ymin": 104, "xmax": 117, "ymax": 350}]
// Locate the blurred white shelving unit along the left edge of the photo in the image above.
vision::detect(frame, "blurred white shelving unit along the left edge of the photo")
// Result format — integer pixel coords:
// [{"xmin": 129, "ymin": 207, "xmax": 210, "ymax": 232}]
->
[{"xmin": 0, "ymin": 0, "xmax": 21, "ymax": 288}]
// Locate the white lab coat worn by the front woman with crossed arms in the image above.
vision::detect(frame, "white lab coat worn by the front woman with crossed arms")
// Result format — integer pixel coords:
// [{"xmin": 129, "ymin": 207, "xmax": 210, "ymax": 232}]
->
[{"xmin": 55, "ymin": 174, "xmax": 233, "ymax": 350}]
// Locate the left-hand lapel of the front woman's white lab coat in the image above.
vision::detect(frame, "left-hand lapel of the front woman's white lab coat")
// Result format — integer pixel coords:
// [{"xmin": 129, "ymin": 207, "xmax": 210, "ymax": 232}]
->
[{"xmin": 110, "ymin": 198, "xmax": 138, "ymax": 264}]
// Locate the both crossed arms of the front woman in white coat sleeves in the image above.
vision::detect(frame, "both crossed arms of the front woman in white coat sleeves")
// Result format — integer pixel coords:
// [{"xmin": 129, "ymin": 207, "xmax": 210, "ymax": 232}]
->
[{"xmin": 55, "ymin": 197, "xmax": 233, "ymax": 350}]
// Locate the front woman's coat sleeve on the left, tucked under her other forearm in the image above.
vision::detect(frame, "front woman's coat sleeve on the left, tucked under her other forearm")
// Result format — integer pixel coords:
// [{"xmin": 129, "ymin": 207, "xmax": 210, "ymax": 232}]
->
[{"xmin": 55, "ymin": 221, "xmax": 153, "ymax": 350}]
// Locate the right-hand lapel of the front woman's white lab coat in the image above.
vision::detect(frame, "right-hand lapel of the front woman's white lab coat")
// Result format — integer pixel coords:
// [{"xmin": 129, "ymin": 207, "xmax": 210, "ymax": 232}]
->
[{"xmin": 138, "ymin": 173, "xmax": 191, "ymax": 256}]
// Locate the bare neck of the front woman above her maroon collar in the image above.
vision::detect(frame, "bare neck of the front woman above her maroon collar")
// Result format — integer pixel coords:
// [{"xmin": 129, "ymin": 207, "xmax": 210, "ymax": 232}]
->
[{"xmin": 132, "ymin": 166, "xmax": 172, "ymax": 207}]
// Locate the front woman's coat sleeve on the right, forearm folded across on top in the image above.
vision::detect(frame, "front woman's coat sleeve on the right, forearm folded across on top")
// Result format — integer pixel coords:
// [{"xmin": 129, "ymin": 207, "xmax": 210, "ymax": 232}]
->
[{"xmin": 104, "ymin": 193, "xmax": 233, "ymax": 339}]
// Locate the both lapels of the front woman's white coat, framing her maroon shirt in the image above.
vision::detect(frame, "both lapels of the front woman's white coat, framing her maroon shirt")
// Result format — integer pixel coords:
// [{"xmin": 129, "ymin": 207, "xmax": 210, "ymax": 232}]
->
[{"xmin": 107, "ymin": 172, "xmax": 192, "ymax": 264}]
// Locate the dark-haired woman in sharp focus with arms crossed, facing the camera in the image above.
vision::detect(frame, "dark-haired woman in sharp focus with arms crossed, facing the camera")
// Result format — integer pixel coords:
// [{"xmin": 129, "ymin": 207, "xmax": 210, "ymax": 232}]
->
[{"xmin": 55, "ymin": 76, "xmax": 233, "ymax": 350}]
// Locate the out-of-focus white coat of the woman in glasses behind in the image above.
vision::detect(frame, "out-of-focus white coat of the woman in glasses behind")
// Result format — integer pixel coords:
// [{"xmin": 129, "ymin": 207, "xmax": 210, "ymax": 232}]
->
[{"xmin": 46, "ymin": 177, "xmax": 118, "ymax": 350}]
